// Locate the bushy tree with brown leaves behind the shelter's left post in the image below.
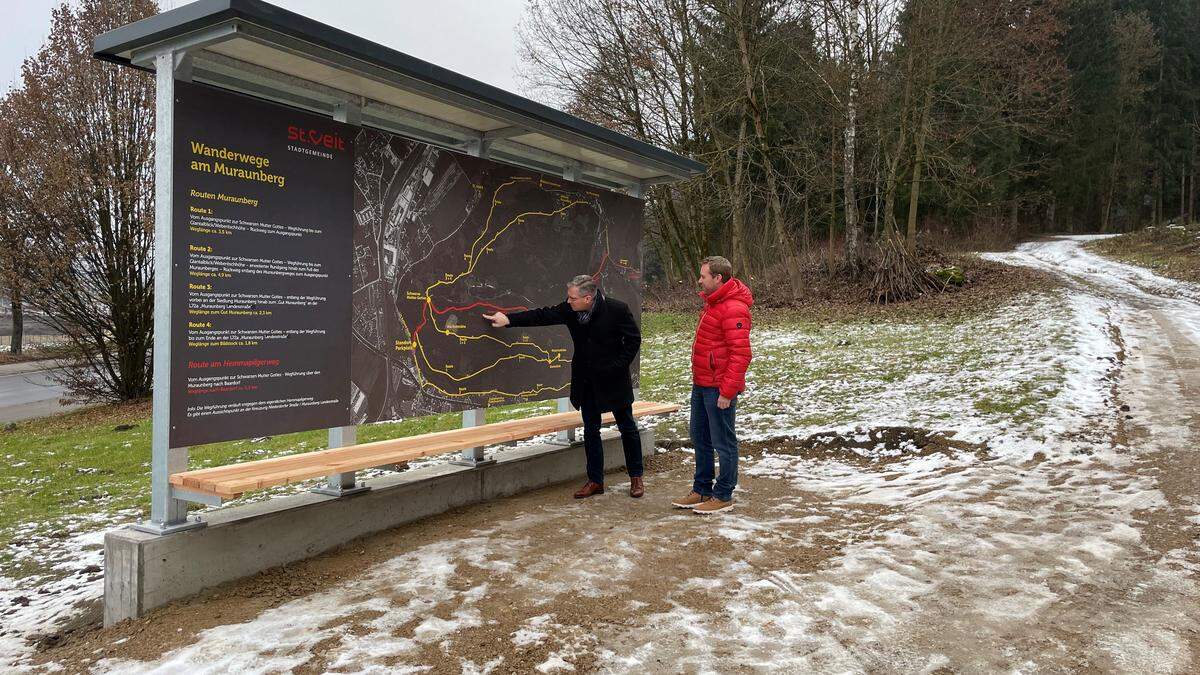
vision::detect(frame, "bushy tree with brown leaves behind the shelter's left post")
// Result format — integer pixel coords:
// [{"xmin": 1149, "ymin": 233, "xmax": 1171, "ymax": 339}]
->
[{"xmin": 6, "ymin": 0, "xmax": 157, "ymax": 400}]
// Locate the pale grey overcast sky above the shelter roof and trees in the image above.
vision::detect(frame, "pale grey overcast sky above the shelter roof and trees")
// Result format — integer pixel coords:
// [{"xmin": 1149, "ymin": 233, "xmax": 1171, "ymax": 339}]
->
[{"xmin": 0, "ymin": 0, "xmax": 524, "ymax": 94}]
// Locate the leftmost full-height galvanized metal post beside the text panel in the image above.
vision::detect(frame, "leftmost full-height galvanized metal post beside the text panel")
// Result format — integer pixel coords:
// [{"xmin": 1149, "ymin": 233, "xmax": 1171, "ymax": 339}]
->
[{"xmin": 133, "ymin": 49, "xmax": 205, "ymax": 534}]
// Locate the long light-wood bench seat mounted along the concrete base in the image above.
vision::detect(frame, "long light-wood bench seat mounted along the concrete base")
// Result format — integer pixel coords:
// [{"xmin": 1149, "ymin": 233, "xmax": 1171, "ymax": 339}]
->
[{"xmin": 170, "ymin": 401, "xmax": 679, "ymax": 500}]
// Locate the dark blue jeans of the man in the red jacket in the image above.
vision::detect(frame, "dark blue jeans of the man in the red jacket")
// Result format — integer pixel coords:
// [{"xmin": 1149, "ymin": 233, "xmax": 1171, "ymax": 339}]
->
[{"xmin": 690, "ymin": 384, "xmax": 738, "ymax": 502}]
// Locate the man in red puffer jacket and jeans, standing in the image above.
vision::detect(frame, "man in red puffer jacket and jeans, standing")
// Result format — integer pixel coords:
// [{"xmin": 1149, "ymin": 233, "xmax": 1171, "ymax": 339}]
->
[{"xmin": 672, "ymin": 256, "xmax": 754, "ymax": 514}]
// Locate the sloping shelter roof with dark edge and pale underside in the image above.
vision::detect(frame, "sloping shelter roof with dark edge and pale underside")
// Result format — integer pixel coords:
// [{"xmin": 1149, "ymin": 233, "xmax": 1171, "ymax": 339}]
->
[{"xmin": 95, "ymin": 0, "xmax": 706, "ymax": 196}]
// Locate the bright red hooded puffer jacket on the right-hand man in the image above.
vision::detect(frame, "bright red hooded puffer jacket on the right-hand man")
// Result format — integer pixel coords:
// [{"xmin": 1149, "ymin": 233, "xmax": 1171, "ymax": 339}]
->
[{"xmin": 691, "ymin": 279, "xmax": 754, "ymax": 399}]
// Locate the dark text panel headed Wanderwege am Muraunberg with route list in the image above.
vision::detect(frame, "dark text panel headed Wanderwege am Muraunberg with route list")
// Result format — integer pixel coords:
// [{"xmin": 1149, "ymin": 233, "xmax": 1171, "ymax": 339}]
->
[{"xmin": 170, "ymin": 83, "xmax": 354, "ymax": 447}]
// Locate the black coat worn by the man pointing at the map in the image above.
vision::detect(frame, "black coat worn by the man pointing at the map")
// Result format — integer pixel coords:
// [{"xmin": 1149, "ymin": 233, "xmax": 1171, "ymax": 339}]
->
[{"xmin": 508, "ymin": 297, "xmax": 642, "ymax": 412}]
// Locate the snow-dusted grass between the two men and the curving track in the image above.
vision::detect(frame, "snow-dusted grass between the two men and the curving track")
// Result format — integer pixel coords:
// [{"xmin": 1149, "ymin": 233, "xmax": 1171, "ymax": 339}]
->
[{"xmin": 642, "ymin": 293, "xmax": 1078, "ymax": 440}]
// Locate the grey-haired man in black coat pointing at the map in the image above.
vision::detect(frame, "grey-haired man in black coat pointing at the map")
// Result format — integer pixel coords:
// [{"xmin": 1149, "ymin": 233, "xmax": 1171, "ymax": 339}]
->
[{"xmin": 484, "ymin": 274, "xmax": 646, "ymax": 500}]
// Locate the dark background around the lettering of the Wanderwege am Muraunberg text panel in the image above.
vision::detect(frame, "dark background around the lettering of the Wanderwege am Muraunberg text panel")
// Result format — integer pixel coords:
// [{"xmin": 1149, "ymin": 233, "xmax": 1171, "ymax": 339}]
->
[{"xmin": 170, "ymin": 83, "xmax": 354, "ymax": 447}]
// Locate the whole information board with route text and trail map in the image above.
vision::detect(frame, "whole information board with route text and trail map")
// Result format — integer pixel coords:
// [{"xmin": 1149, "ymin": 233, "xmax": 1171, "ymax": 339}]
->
[{"xmin": 170, "ymin": 83, "xmax": 642, "ymax": 447}]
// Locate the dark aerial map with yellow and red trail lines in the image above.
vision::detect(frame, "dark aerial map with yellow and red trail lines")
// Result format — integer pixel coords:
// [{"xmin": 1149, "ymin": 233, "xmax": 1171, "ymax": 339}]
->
[{"xmin": 350, "ymin": 130, "xmax": 642, "ymax": 424}]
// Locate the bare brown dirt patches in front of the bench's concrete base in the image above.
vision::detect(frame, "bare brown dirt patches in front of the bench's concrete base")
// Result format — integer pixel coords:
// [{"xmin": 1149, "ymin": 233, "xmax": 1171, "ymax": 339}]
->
[{"xmin": 32, "ymin": 450, "xmax": 884, "ymax": 673}]
